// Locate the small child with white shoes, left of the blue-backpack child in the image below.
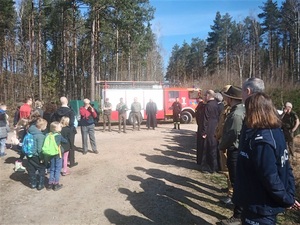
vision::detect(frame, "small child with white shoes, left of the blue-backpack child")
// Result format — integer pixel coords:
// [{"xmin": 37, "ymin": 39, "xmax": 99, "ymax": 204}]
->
[{"xmin": 15, "ymin": 118, "xmax": 28, "ymax": 172}]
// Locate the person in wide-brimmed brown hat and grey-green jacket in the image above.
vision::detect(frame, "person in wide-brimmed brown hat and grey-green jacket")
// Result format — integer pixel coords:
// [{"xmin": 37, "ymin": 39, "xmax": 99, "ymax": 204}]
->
[{"xmin": 218, "ymin": 86, "xmax": 245, "ymax": 219}]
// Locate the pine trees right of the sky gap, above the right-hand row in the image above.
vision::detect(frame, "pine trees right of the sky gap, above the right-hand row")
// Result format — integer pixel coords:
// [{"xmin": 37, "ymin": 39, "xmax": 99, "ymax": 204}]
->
[{"xmin": 166, "ymin": 0, "xmax": 300, "ymax": 87}]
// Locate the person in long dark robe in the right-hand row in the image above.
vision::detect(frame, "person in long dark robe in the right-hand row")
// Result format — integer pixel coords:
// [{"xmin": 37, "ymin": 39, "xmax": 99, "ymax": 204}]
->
[{"xmin": 200, "ymin": 90, "xmax": 220, "ymax": 173}]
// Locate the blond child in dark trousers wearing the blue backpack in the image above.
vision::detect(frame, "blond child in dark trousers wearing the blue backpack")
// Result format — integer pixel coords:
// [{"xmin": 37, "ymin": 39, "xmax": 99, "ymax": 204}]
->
[{"xmin": 27, "ymin": 118, "xmax": 47, "ymax": 190}]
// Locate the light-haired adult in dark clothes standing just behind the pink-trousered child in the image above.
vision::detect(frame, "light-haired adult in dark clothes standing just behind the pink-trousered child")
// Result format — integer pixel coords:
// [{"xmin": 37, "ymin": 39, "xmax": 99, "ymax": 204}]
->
[{"xmin": 52, "ymin": 97, "xmax": 78, "ymax": 168}]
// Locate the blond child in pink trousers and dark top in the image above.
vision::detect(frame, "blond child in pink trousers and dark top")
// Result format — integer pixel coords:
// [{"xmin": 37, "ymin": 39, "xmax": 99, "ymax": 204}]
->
[{"xmin": 60, "ymin": 116, "xmax": 71, "ymax": 176}]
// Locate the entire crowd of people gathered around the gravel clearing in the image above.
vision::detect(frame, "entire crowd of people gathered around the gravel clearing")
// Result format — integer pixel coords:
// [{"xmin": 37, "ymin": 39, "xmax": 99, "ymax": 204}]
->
[{"xmin": 0, "ymin": 78, "xmax": 300, "ymax": 225}]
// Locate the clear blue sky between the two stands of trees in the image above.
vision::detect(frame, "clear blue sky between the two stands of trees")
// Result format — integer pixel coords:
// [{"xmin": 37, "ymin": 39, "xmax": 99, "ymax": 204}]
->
[{"xmin": 150, "ymin": 0, "xmax": 283, "ymax": 69}]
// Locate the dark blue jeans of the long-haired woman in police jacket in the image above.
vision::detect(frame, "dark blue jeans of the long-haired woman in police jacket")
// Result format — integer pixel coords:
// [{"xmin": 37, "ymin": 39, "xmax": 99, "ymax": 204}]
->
[{"xmin": 241, "ymin": 210, "xmax": 276, "ymax": 225}]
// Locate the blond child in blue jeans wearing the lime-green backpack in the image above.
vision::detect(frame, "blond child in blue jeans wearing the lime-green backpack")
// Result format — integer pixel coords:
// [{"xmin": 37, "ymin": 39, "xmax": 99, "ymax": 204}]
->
[{"xmin": 47, "ymin": 121, "xmax": 67, "ymax": 191}]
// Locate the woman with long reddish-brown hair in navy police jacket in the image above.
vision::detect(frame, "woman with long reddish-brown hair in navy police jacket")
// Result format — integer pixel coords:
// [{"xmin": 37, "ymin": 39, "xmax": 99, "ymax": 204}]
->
[{"xmin": 233, "ymin": 93, "xmax": 300, "ymax": 225}]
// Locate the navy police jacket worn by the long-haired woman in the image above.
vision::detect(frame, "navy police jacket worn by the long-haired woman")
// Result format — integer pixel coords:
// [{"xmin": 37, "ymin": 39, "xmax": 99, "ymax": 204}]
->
[{"xmin": 233, "ymin": 128, "xmax": 295, "ymax": 216}]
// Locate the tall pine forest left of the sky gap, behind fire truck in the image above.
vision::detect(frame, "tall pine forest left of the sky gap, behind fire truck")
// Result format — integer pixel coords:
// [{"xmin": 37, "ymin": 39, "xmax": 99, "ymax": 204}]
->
[{"xmin": 0, "ymin": 0, "xmax": 163, "ymax": 102}]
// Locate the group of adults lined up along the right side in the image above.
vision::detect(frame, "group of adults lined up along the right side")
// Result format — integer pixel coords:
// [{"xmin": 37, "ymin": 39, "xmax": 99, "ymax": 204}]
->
[{"xmin": 196, "ymin": 78, "xmax": 300, "ymax": 225}]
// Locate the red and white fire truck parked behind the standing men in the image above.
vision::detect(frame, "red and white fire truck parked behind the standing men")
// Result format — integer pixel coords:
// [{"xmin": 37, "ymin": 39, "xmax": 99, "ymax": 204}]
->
[{"xmin": 98, "ymin": 81, "xmax": 201, "ymax": 124}]
